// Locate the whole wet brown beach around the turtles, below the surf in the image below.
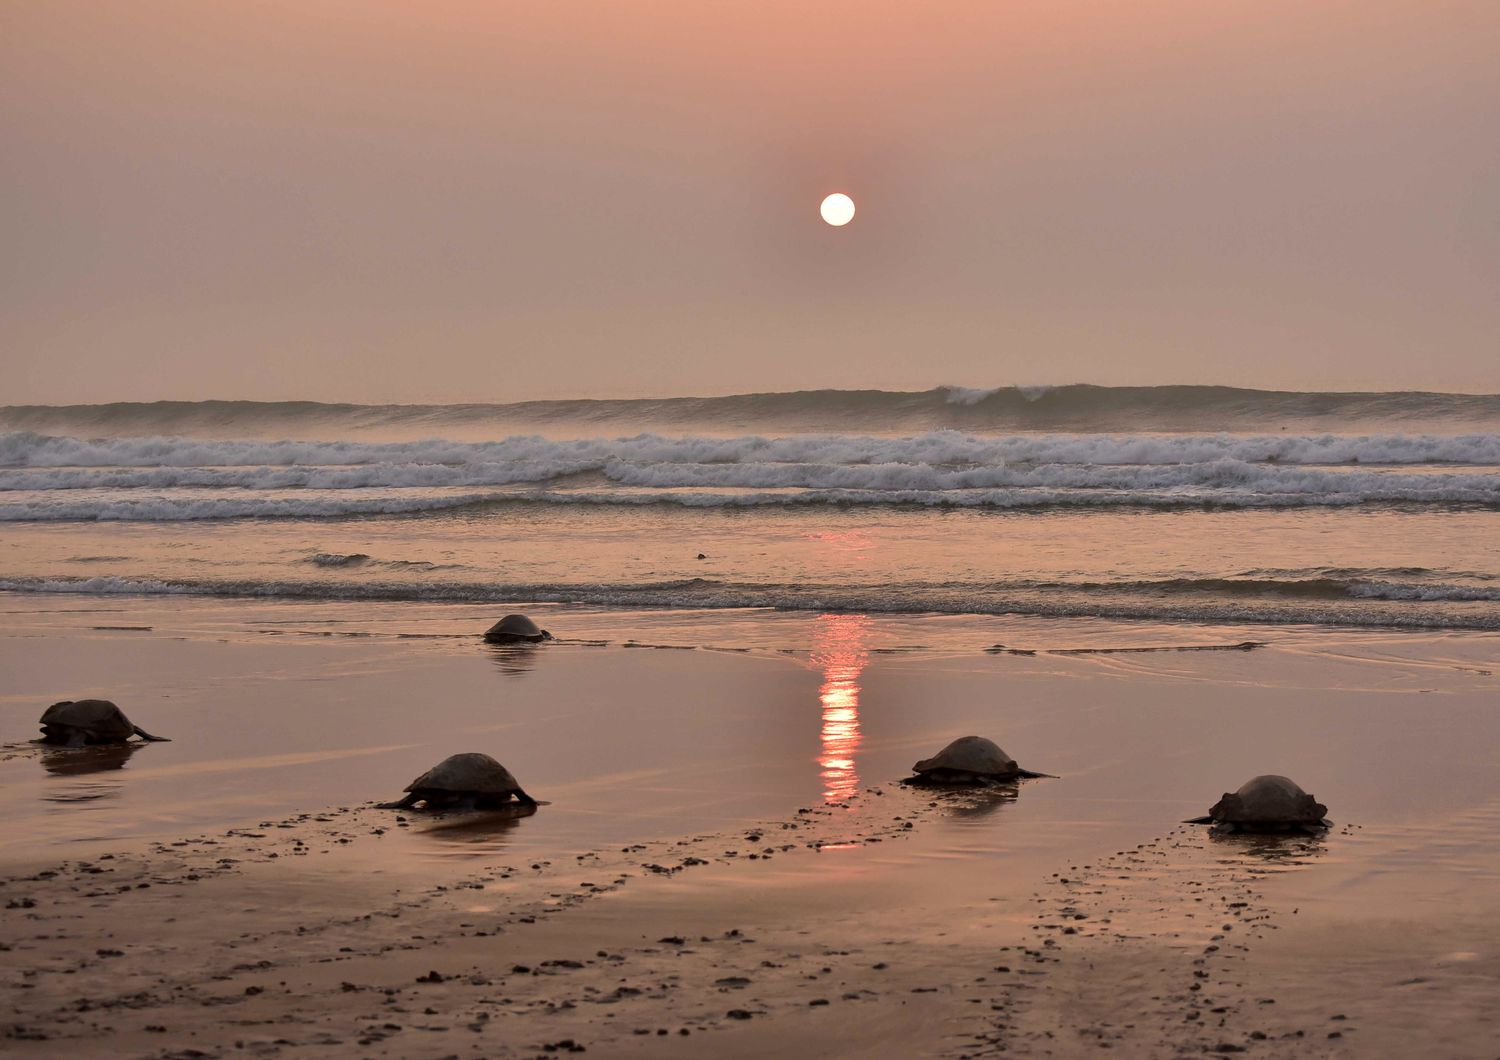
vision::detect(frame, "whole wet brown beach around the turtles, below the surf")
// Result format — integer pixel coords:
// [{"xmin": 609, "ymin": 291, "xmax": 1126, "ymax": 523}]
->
[{"xmin": 0, "ymin": 597, "xmax": 1500, "ymax": 1057}]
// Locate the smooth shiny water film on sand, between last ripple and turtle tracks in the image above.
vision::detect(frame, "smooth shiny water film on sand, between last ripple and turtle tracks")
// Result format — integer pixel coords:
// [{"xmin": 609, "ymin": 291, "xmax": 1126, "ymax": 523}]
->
[{"xmin": 0, "ymin": 597, "xmax": 1500, "ymax": 859}]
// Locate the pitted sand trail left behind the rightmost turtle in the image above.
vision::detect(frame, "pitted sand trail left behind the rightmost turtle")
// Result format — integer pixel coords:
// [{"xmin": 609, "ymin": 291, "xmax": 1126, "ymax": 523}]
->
[{"xmin": 963, "ymin": 826, "xmax": 1353, "ymax": 1057}]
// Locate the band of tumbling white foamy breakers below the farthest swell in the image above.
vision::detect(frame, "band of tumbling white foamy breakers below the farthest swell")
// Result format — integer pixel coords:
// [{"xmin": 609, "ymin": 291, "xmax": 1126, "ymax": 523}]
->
[{"xmin": 0, "ymin": 430, "xmax": 1500, "ymax": 522}]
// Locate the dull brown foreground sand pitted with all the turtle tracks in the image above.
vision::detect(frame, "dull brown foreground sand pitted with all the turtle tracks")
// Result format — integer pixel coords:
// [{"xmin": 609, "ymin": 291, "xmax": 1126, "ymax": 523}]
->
[{"xmin": 0, "ymin": 786, "xmax": 1380, "ymax": 1057}]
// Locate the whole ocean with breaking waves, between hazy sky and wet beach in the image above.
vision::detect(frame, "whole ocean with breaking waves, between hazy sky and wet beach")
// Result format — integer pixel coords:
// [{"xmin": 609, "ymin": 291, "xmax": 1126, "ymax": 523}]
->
[{"xmin": 0, "ymin": 385, "xmax": 1500, "ymax": 630}]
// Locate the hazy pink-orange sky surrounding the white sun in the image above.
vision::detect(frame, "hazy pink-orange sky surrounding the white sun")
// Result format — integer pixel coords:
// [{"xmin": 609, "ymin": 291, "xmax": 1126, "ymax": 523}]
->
[{"xmin": 0, "ymin": 0, "xmax": 1500, "ymax": 403}]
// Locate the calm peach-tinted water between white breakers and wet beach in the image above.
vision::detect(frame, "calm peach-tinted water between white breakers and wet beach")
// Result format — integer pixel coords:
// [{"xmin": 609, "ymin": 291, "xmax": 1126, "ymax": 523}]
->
[{"xmin": 0, "ymin": 503, "xmax": 1500, "ymax": 628}]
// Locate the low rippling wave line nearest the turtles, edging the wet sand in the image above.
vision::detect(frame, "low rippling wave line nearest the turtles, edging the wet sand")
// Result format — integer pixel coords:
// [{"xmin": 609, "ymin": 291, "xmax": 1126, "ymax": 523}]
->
[{"xmin": 0, "ymin": 576, "xmax": 1500, "ymax": 630}]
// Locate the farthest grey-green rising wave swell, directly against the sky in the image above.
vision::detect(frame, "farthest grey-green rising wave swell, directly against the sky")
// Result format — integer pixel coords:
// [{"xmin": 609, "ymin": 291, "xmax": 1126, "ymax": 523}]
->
[{"xmin": 0, "ymin": 384, "xmax": 1500, "ymax": 436}]
